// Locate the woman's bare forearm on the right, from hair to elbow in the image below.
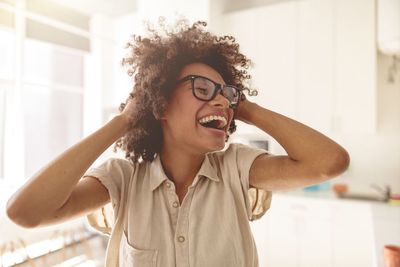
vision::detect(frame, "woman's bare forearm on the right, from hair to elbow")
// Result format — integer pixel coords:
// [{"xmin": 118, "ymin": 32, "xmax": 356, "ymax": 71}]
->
[{"xmin": 240, "ymin": 101, "xmax": 349, "ymax": 173}]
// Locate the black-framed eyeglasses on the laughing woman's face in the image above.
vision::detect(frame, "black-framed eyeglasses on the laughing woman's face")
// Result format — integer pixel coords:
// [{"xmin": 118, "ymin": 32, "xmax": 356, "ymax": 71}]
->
[{"xmin": 177, "ymin": 75, "xmax": 242, "ymax": 109}]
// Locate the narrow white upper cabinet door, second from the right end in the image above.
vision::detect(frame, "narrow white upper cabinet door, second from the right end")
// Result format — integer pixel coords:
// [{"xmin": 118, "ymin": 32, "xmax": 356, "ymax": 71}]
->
[{"xmin": 296, "ymin": 0, "xmax": 334, "ymax": 132}]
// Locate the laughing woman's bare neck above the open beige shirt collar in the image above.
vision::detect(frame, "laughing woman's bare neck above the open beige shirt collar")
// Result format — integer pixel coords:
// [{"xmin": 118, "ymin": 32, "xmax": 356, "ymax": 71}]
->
[{"xmin": 160, "ymin": 145, "xmax": 205, "ymax": 186}]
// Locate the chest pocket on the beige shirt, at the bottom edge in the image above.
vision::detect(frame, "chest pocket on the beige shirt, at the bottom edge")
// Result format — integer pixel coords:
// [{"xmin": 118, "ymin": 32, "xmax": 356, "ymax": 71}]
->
[{"xmin": 119, "ymin": 233, "xmax": 158, "ymax": 267}]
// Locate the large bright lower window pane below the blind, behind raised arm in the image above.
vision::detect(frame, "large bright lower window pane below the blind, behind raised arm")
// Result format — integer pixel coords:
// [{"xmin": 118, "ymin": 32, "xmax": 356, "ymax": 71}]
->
[{"xmin": 22, "ymin": 39, "xmax": 84, "ymax": 177}]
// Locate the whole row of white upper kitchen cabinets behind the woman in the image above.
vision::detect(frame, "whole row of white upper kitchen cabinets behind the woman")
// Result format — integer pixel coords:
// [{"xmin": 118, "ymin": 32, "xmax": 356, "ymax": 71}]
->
[{"xmin": 222, "ymin": 0, "xmax": 376, "ymax": 138}]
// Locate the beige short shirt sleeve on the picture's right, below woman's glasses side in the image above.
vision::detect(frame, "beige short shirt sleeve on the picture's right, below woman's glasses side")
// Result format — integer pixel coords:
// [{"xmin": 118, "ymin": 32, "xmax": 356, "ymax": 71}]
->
[{"xmin": 232, "ymin": 144, "xmax": 272, "ymax": 221}]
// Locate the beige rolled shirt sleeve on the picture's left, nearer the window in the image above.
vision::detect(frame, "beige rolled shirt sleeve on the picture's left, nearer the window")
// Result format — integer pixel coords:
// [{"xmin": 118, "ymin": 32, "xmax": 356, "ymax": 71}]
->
[{"xmin": 82, "ymin": 158, "xmax": 134, "ymax": 235}]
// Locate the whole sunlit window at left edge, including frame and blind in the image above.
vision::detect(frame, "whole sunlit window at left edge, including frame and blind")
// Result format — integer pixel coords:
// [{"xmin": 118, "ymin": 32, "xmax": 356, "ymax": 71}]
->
[{"xmin": 0, "ymin": 0, "xmax": 90, "ymax": 183}]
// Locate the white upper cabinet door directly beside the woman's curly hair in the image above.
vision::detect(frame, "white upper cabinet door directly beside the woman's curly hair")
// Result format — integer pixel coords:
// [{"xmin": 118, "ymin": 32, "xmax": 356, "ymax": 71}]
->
[{"xmin": 222, "ymin": 2, "xmax": 296, "ymax": 140}]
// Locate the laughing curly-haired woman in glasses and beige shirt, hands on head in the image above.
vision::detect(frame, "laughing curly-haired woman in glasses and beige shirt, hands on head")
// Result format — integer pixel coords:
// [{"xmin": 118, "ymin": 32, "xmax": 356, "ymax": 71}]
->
[{"xmin": 7, "ymin": 21, "xmax": 349, "ymax": 267}]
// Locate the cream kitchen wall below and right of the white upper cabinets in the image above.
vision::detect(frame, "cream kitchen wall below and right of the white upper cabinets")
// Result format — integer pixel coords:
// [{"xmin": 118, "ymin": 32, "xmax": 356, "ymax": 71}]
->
[{"xmin": 331, "ymin": 53, "xmax": 400, "ymax": 193}]
